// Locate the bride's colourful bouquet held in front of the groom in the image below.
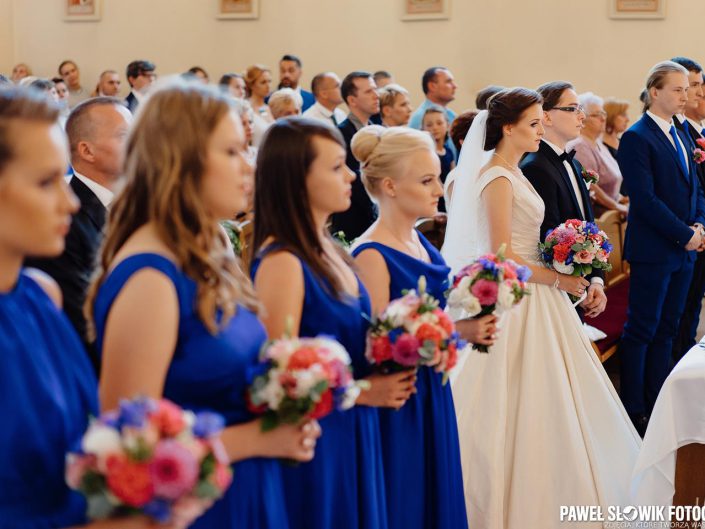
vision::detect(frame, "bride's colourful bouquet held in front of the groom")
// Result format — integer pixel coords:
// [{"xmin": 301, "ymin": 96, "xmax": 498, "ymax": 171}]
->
[{"xmin": 539, "ymin": 219, "xmax": 612, "ymax": 302}]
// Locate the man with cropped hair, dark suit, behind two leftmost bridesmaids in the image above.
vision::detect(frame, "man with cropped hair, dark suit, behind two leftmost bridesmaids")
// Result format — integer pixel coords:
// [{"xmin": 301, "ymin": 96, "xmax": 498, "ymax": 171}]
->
[{"xmin": 27, "ymin": 97, "xmax": 132, "ymax": 372}]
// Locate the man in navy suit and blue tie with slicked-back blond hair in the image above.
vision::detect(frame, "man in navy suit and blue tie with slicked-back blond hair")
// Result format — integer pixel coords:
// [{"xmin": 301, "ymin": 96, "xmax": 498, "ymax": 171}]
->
[{"xmin": 618, "ymin": 61, "xmax": 705, "ymax": 435}]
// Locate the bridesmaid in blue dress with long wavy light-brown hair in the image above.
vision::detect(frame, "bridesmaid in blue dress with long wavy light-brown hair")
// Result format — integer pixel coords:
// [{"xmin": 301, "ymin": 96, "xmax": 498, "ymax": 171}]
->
[{"xmin": 89, "ymin": 82, "xmax": 320, "ymax": 529}]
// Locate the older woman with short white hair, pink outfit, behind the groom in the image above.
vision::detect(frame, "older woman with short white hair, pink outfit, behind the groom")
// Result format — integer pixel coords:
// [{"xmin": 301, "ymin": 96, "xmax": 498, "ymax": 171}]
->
[{"xmin": 567, "ymin": 92, "xmax": 628, "ymax": 216}]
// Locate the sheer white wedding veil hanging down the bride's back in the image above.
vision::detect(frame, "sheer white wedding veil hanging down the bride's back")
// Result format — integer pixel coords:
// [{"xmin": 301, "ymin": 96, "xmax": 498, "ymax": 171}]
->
[{"xmin": 441, "ymin": 110, "xmax": 494, "ymax": 274}]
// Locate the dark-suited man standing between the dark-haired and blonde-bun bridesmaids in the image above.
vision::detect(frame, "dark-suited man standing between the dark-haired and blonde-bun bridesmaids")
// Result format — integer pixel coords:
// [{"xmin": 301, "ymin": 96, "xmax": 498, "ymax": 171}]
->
[{"xmin": 331, "ymin": 72, "xmax": 379, "ymax": 241}]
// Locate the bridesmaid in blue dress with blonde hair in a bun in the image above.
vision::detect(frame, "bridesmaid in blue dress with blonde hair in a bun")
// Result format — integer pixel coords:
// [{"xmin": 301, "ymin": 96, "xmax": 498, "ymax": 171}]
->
[{"xmin": 352, "ymin": 126, "xmax": 495, "ymax": 529}]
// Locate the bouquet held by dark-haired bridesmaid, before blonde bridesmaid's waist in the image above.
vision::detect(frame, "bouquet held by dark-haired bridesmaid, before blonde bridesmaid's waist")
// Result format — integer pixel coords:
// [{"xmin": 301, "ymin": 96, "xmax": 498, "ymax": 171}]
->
[{"xmin": 366, "ymin": 276, "xmax": 466, "ymax": 384}]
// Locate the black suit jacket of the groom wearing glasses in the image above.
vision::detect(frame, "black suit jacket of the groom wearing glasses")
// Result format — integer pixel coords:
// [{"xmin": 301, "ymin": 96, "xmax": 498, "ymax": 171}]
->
[{"xmin": 520, "ymin": 141, "xmax": 604, "ymax": 286}]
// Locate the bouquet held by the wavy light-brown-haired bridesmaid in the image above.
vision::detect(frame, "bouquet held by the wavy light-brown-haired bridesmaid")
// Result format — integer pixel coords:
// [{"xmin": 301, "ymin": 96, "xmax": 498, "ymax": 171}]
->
[{"xmin": 246, "ymin": 336, "xmax": 364, "ymax": 431}]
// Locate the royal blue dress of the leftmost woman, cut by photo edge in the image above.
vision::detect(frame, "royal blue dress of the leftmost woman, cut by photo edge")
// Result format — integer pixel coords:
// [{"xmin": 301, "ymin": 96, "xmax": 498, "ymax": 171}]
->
[{"xmin": 0, "ymin": 273, "xmax": 98, "ymax": 529}]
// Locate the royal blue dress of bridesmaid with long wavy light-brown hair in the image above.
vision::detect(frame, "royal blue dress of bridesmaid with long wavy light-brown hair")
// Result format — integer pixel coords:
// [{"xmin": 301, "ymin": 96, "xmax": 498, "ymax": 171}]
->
[{"xmin": 95, "ymin": 253, "xmax": 289, "ymax": 529}]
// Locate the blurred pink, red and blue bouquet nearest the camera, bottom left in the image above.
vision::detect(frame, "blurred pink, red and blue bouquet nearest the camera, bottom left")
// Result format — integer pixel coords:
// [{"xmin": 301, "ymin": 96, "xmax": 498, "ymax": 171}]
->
[{"xmin": 66, "ymin": 398, "xmax": 232, "ymax": 523}]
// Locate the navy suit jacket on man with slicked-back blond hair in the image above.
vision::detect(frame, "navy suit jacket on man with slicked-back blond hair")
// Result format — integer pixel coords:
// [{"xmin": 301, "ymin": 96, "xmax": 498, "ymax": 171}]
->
[{"xmin": 617, "ymin": 114, "xmax": 705, "ymax": 264}]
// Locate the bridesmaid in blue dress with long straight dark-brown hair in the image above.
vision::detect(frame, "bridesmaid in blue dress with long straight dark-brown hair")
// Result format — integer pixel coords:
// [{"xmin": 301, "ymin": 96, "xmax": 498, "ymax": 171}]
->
[{"xmin": 252, "ymin": 118, "xmax": 412, "ymax": 529}]
